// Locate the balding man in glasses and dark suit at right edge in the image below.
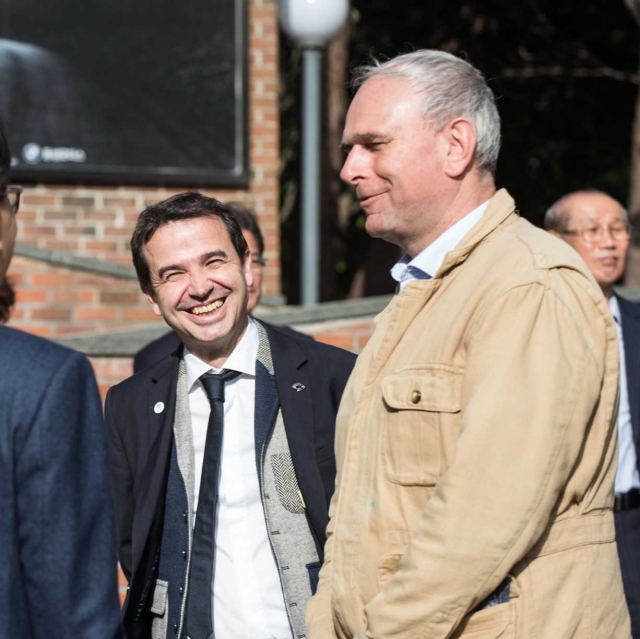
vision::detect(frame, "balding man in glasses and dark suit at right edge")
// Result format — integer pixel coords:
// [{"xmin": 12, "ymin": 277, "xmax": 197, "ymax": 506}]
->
[{"xmin": 545, "ymin": 190, "xmax": 640, "ymax": 638}]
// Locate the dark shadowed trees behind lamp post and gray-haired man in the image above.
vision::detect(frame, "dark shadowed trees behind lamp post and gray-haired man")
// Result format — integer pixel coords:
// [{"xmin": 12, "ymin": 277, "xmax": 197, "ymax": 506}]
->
[{"xmin": 282, "ymin": 0, "xmax": 640, "ymax": 301}]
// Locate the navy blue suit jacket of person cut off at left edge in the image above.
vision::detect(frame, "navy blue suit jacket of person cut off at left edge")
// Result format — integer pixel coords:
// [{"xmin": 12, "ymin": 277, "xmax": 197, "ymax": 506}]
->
[{"xmin": 0, "ymin": 326, "xmax": 121, "ymax": 639}]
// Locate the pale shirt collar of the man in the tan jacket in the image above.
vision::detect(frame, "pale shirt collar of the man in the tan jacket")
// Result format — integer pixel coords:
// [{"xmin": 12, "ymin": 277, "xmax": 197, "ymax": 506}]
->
[{"xmin": 391, "ymin": 200, "xmax": 489, "ymax": 290}]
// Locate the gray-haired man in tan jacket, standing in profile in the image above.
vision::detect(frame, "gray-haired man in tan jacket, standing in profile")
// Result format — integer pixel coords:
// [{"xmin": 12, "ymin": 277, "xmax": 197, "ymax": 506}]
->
[{"xmin": 307, "ymin": 51, "xmax": 630, "ymax": 639}]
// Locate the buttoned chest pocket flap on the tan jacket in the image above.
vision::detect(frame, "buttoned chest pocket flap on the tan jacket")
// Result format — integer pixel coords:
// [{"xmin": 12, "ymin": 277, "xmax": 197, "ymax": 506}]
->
[{"xmin": 382, "ymin": 364, "xmax": 462, "ymax": 413}]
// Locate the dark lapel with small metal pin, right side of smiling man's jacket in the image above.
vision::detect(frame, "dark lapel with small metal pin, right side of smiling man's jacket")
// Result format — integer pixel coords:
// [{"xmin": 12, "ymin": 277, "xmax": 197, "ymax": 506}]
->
[{"xmin": 265, "ymin": 326, "xmax": 328, "ymax": 539}]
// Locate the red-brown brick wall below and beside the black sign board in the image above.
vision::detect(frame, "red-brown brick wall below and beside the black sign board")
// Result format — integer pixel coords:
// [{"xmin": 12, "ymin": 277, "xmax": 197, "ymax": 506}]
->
[{"xmin": 9, "ymin": 0, "xmax": 280, "ymax": 344}]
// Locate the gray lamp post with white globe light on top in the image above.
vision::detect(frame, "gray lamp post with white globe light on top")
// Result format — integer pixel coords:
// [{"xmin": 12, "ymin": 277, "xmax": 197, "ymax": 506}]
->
[{"xmin": 280, "ymin": 0, "xmax": 349, "ymax": 305}]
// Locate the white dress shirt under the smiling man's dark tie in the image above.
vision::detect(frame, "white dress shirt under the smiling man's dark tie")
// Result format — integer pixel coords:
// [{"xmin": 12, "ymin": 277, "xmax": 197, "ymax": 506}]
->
[{"xmin": 184, "ymin": 319, "xmax": 292, "ymax": 639}]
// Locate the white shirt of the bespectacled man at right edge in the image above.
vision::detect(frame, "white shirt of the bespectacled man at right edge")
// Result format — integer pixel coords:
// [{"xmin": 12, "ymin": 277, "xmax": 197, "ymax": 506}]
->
[{"xmin": 609, "ymin": 295, "xmax": 640, "ymax": 495}]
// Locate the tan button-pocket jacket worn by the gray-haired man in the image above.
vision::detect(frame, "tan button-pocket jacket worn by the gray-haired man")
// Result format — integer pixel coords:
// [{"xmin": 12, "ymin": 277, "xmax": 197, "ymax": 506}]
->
[{"xmin": 307, "ymin": 191, "xmax": 630, "ymax": 639}]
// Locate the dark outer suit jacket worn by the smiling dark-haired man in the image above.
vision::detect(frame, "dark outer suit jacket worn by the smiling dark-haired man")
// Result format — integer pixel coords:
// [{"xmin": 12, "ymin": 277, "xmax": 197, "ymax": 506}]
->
[{"xmin": 106, "ymin": 324, "xmax": 355, "ymax": 639}]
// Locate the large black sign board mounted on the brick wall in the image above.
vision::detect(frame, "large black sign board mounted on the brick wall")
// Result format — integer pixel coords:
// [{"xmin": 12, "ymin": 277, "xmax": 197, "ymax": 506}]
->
[{"xmin": 0, "ymin": 0, "xmax": 248, "ymax": 187}]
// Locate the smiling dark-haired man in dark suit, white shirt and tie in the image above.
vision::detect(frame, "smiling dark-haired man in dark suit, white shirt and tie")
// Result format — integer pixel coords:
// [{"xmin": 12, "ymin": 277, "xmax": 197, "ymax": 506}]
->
[{"xmin": 106, "ymin": 193, "xmax": 355, "ymax": 639}]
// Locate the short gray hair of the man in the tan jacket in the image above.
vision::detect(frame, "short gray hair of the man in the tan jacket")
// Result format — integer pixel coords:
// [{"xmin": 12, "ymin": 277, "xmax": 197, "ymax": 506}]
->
[{"xmin": 352, "ymin": 49, "xmax": 500, "ymax": 175}]
